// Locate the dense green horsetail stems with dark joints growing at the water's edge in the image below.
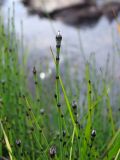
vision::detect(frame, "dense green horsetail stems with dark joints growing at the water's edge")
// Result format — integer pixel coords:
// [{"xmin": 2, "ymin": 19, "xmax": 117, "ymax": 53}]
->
[{"xmin": 0, "ymin": 11, "xmax": 120, "ymax": 160}]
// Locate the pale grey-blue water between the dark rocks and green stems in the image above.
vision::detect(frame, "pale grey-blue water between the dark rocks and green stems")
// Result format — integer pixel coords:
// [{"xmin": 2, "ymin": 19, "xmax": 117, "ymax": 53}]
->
[{"xmin": 2, "ymin": 0, "xmax": 120, "ymax": 78}]
